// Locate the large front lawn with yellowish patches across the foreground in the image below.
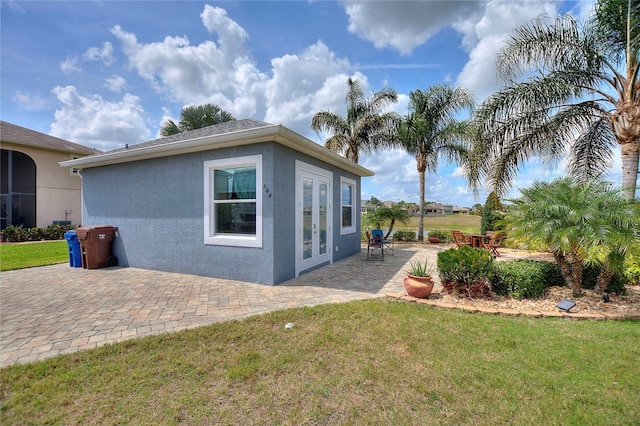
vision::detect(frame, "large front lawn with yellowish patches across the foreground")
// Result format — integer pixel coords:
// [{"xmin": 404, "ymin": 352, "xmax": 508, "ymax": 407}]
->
[{"xmin": 0, "ymin": 299, "xmax": 640, "ymax": 425}]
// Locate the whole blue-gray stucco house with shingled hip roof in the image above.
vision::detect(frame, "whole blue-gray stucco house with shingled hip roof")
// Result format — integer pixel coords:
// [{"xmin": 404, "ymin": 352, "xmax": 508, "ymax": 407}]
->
[{"xmin": 60, "ymin": 119, "xmax": 373, "ymax": 285}]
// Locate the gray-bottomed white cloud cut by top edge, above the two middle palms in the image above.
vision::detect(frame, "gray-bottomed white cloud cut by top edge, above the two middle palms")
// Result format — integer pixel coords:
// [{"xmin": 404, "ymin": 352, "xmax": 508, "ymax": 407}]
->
[{"xmin": 344, "ymin": 1, "xmax": 484, "ymax": 55}]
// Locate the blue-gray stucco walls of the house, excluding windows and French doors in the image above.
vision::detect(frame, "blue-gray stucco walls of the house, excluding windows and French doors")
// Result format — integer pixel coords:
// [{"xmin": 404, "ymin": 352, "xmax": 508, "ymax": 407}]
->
[{"xmin": 82, "ymin": 143, "xmax": 360, "ymax": 284}]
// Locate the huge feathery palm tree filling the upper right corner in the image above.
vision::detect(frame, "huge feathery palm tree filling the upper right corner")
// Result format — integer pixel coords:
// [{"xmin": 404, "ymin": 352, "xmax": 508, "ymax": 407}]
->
[{"xmin": 468, "ymin": 0, "xmax": 640, "ymax": 199}]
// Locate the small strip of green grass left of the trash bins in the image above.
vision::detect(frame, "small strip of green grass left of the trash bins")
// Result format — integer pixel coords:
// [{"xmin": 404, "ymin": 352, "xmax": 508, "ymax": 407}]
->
[{"xmin": 0, "ymin": 240, "xmax": 69, "ymax": 271}]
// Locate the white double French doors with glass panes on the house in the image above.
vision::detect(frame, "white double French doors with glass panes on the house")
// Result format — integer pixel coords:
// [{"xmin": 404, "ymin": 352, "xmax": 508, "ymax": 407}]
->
[{"xmin": 296, "ymin": 161, "xmax": 333, "ymax": 276}]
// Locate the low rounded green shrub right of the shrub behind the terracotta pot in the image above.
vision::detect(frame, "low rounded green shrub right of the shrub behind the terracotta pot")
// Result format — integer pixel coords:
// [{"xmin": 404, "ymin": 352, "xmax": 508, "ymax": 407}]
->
[{"xmin": 491, "ymin": 259, "xmax": 564, "ymax": 299}]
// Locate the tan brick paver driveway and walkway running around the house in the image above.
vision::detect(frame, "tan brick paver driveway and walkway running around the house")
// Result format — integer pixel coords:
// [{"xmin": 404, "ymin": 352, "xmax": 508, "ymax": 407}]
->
[{"xmin": 0, "ymin": 246, "xmax": 444, "ymax": 366}]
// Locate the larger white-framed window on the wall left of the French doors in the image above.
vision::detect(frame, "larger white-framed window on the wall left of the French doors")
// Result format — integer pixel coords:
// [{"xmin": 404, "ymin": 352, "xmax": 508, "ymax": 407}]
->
[{"xmin": 204, "ymin": 155, "xmax": 262, "ymax": 247}]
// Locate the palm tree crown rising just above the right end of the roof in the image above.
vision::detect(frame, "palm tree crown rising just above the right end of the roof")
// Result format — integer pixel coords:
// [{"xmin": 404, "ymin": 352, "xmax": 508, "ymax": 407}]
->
[{"xmin": 311, "ymin": 77, "xmax": 398, "ymax": 164}]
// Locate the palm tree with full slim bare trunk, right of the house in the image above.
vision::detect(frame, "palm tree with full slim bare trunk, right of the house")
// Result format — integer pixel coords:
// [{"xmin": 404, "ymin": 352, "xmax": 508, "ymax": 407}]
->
[{"xmin": 397, "ymin": 85, "xmax": 474, "ymax": 241}]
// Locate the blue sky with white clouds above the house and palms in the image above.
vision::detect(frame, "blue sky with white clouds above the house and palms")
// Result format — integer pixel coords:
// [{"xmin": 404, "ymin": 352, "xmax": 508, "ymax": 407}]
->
[{"xmin": 0, "ymin": 0, "xmax": 604, "ymax": 206}]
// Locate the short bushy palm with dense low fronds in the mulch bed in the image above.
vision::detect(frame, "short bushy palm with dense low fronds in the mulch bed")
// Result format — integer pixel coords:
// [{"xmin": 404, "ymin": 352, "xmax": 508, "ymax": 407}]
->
[{"xmin": 506, "ymin": 177, "xmax": 638, "ymax": 296}]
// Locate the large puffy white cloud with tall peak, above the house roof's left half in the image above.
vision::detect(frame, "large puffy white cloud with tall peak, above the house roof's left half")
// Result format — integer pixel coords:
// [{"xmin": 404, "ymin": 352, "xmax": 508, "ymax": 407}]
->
[{"xmin": 111, "ymin": 6, "xmax": 267, "ymax": 118}]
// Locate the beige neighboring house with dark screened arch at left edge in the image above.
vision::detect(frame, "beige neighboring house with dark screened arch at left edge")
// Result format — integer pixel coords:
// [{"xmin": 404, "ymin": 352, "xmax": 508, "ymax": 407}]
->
[{"xmin": 0, "ymin": 121, "xmax": 99, "ymax": 229}]
